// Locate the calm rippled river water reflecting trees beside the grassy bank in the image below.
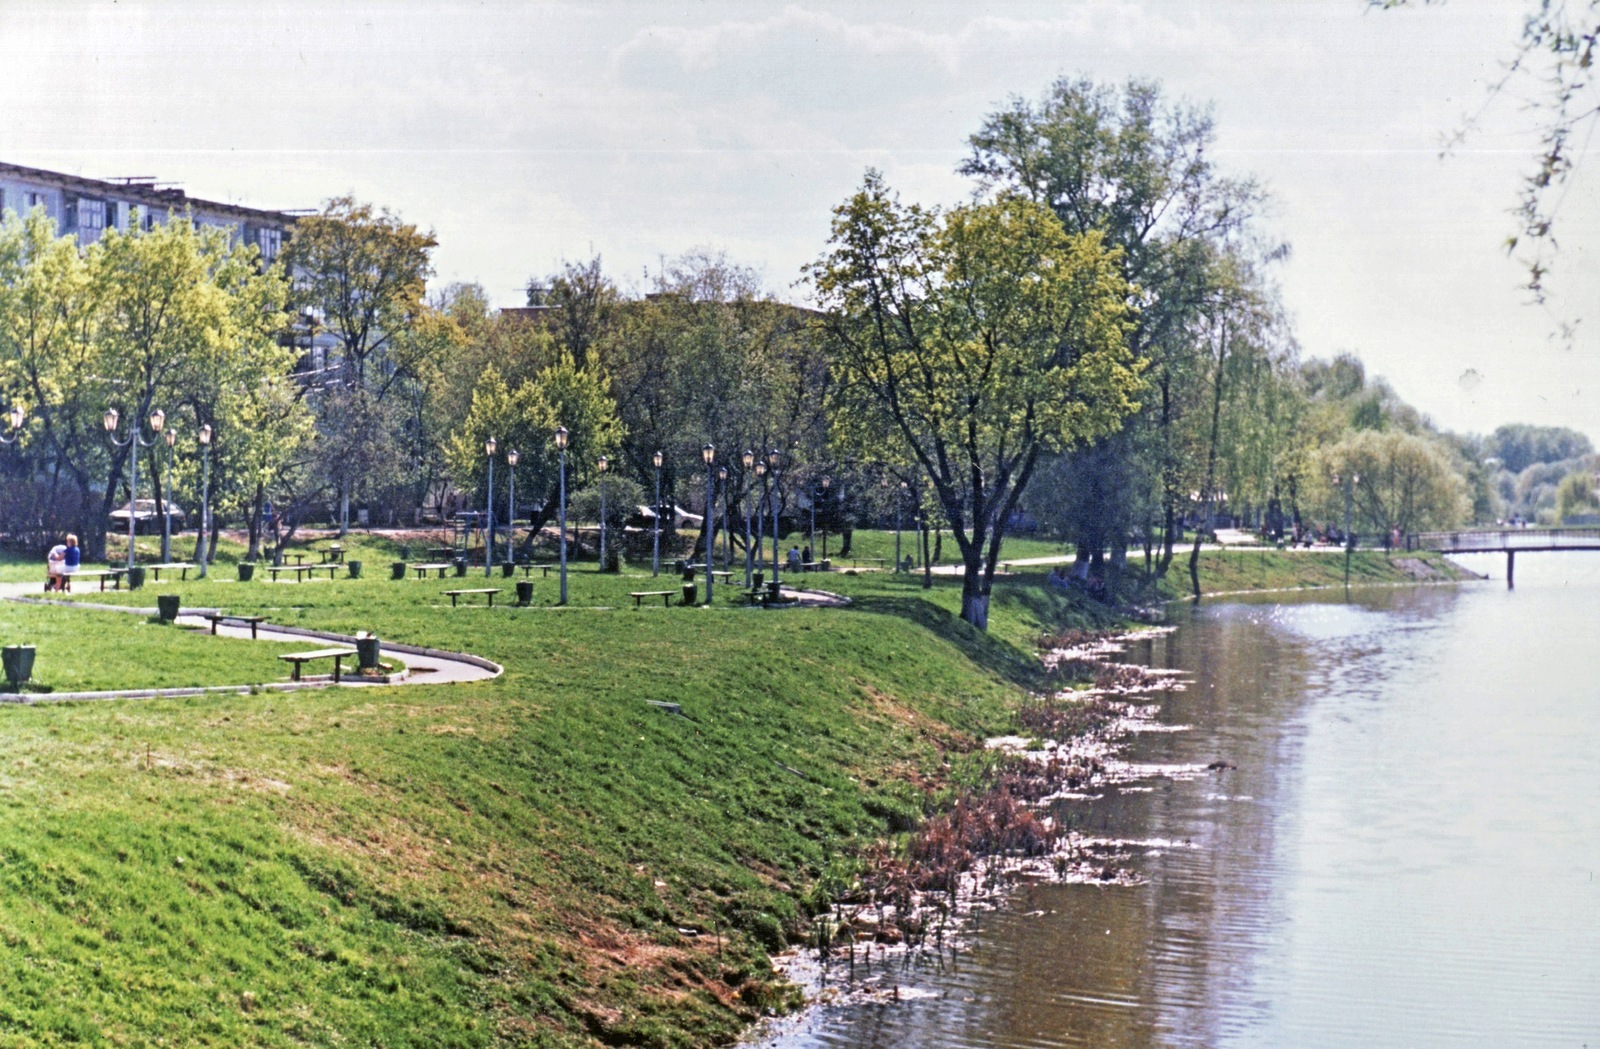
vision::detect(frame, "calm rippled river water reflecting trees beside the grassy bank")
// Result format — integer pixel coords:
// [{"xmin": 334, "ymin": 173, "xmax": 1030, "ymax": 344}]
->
[{"xmin": 757, "ymin": 553, "xmax": 1600, "ymax": 1049}]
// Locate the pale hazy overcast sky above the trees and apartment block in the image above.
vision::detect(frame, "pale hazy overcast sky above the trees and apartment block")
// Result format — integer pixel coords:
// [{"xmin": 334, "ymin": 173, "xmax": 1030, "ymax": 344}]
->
[{"xmin": 0, "ymin": 0, "xmax": 1600, "ymax": 445}]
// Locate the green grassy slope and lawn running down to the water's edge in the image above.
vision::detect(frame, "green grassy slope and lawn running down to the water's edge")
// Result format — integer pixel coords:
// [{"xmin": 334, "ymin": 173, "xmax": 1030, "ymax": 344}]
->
[{"xmin": 0, "ymin": 540, "xmax": 1472, "ymax": 1046}]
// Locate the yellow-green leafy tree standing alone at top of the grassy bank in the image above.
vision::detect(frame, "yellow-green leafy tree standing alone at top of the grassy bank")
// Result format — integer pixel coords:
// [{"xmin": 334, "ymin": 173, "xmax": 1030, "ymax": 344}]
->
[{"xmin": 810, "ymin": 173, "xmax": 1139, "ymax": 628}]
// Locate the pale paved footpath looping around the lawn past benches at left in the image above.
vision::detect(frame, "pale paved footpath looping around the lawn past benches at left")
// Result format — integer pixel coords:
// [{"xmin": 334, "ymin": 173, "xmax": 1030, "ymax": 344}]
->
[{"xmin": 0, "ymin": 582, "xmax": 506, "ymax": 704}]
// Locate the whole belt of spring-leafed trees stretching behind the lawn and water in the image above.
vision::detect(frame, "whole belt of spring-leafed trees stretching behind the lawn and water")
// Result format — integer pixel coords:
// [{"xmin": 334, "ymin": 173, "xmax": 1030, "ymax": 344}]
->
[{"xmin": 0, "ymin": 78, "xmax": 1597, "ymax": 627}]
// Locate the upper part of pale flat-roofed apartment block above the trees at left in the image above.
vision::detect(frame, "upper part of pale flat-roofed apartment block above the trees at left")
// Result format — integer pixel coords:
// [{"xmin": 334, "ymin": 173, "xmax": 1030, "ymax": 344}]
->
[{"xmin": 0, "ymin": 163, "xmax": 296, "ymax": 262}]
